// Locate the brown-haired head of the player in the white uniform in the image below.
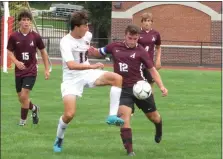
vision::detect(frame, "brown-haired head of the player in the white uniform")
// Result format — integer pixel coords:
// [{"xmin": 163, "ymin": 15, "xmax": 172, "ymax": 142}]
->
[{"xmin": 70, "ymin": 10, "xmax": 89, "ymax": 38}]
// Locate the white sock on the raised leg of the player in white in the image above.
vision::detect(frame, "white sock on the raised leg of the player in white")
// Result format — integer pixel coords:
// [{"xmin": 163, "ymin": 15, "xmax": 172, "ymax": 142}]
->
[{"xmin": 109, "ymin": 86, "xmax": 122, "ymax": 115}]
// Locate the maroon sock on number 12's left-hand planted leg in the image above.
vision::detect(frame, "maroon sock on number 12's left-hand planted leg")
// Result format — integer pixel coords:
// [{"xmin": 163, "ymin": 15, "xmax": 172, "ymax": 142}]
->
[{"xmin": 120, "ymin": 128, "xmax": 133, "ymax": 153}]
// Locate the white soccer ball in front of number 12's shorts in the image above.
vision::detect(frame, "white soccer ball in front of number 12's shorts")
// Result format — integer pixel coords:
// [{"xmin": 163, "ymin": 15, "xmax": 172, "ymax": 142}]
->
[{"xmin": 133, "ymin": 80, "xmax": 152, "ymax": 100}]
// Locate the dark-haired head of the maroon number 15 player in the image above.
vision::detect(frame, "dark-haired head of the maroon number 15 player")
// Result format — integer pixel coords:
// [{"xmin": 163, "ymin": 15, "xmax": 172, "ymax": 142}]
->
[{"xmin": 18, "ymin": 9, "xmax": 33, "ymax": 29}]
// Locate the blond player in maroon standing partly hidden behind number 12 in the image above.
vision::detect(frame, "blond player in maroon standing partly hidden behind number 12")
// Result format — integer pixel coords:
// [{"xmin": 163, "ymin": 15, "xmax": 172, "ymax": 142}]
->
[{"xmin": 138, "ymin": 13, "xmax": 161, "ymax": 88}]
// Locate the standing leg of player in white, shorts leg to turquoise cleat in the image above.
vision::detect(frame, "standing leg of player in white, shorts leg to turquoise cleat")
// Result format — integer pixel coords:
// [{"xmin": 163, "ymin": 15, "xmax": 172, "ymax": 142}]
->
[{"xmin": 53, "ymin": 80, "xmax": 84, "ymax": 152}]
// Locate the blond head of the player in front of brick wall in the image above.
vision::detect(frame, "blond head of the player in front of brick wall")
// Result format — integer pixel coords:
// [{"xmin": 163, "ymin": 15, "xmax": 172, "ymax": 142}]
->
[{"xmin": 141, "ymin": 12, "xmax": 153, "ymax": 30}]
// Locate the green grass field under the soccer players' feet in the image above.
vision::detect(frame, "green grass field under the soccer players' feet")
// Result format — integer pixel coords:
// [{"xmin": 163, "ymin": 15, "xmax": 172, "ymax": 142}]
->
[{"xmin": 1, "ymin": 66, "xmax": 221, "ymax": 159}]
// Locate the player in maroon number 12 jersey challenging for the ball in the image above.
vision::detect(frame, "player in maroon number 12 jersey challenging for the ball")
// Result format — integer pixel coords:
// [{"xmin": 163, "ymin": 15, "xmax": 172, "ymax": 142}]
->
[{"xmin": 88, "ymin": 25, "xmax": 168, "ymax": 156}]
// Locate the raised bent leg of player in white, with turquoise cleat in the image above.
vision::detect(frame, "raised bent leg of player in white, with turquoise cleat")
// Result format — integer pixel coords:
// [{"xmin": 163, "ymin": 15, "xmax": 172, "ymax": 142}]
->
[{"xmin": 88, "ymin": 70, "xmax": 124, "ymax": 125}]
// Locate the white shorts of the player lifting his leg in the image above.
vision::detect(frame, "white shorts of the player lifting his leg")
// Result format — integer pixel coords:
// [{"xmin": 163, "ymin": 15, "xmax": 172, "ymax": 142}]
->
[{"xmin": 61, "ymin": 69, "xmax": 107, "ymax": 97}]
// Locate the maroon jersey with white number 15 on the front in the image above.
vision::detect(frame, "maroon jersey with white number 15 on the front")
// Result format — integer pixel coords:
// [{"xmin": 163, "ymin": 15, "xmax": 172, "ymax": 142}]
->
[{"xmin": 7, "ymin": 31, "xmax": 45, "ymax": 77}]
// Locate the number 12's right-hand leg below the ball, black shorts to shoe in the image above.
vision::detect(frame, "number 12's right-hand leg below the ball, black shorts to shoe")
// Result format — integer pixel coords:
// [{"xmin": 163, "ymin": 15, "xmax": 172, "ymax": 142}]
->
[{"xmin": 136, "ymin": 94, "xmax": 162, "ymax": 143}]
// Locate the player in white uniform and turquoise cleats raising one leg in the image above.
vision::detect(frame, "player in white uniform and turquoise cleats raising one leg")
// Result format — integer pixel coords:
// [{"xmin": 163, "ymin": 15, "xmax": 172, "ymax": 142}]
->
[{"xmin": 53, "ymin": 11, "xmax": 124, "ymax": 152}]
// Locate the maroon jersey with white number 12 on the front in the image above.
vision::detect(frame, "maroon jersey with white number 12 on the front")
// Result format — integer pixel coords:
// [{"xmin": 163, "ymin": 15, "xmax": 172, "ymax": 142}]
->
[{"xmin": 102, "ymin": 42, "xmax": 153, "ymax": 88}]
